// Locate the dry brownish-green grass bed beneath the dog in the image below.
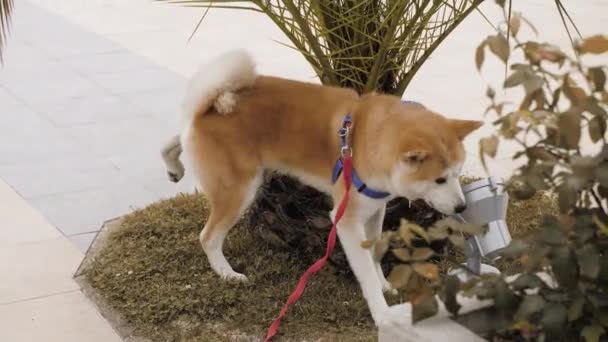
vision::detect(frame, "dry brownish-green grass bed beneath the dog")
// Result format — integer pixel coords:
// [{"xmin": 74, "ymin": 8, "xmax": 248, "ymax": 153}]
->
[{"xmin": 78, "ymin": 188, "xmax": 554, "ymax": 341}]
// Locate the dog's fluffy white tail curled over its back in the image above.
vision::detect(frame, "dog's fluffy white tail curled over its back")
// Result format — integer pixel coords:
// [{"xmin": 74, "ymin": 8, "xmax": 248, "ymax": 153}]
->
[{"xmin": 182, "ymin": 49, "xmax": 256, "ymax": 127}]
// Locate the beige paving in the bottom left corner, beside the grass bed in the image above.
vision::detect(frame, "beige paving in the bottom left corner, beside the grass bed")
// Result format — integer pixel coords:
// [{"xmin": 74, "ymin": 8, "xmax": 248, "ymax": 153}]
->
[{"xmin": 0, "ymin": 180, "xmax": 121, "ymax": 342}]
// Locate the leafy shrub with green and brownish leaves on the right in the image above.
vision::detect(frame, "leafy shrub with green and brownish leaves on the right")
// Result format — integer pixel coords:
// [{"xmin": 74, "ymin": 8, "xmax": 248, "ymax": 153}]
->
[{"xmin": 373, "ymin": 3, "xmax": 608, "ymax": 342}]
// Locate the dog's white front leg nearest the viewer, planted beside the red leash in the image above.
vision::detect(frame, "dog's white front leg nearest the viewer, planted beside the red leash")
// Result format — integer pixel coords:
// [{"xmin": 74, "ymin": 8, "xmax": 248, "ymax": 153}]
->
[{"xmin": 331, "ymin": 209, "xmax": 388, "ymax": 325}]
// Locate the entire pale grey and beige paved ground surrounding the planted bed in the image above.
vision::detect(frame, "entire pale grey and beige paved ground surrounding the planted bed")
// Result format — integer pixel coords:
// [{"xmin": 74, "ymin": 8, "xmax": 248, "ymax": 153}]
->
[{"xmin": 0, "ymin": 0, "xmax": 608, "ymax": 342}]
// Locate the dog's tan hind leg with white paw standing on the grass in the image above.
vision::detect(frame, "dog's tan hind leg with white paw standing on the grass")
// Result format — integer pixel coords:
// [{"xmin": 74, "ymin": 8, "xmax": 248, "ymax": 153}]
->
[{"xmin": 200, "ymin": 170, "xmax": 262, "ymax": 281}]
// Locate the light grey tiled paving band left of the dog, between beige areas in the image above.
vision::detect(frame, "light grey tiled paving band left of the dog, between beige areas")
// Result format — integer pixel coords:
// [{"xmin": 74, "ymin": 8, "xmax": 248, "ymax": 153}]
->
[{"xmin": 0, "ymin": 1, "xmax": 193, "ymax": 251}]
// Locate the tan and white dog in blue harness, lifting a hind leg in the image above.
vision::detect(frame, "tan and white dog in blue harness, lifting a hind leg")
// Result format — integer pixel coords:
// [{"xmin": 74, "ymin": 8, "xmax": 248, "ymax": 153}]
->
[{"xmin": 162, "ymin": 51, "xmax": 481, "ymax": 324}]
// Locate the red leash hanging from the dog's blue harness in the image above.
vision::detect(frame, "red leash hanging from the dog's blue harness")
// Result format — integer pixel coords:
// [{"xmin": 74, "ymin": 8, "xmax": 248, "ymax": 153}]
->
[{"xmin": 264, "ymin": 153, "xmax": 352, "ymax": 342}]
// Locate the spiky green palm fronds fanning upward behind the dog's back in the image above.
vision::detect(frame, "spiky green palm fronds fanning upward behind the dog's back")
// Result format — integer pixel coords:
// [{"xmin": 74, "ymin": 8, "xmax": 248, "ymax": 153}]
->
[{"xmin": 158, "ymin": 0, "xmax": 483, "ymax": 95}]
